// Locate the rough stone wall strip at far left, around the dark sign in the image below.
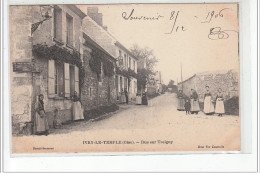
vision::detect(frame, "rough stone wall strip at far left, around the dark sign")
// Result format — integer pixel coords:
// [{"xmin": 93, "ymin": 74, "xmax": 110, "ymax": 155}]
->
[{"xmin": 9, "ymin": 6, "xmax": 32, "ymax": 133}]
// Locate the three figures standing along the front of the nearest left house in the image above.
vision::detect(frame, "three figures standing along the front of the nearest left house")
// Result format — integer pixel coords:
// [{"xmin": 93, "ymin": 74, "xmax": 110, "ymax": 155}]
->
[{"xmin": 33, "ymin": 91, "xmax": 84, "ymax": 136}]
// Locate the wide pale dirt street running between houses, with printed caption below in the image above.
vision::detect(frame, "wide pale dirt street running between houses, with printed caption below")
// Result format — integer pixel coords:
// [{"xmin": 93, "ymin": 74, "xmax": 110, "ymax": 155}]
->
[{"xmin": 13, "ymin": 93, "xmax": 240, "ymax": 153}]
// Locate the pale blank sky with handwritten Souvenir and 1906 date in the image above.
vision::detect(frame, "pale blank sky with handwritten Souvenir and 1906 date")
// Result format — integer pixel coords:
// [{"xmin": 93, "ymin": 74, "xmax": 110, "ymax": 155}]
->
[{"xmin": 79, "ymin": 4, "xmax": 239, "ymax": 84}]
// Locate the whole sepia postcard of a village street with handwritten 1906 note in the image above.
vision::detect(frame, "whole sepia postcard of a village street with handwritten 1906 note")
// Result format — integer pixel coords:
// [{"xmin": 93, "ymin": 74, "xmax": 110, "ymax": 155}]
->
[{"xmin": 9, "ymin": 3, "xmax": 240, "ymax": 154}]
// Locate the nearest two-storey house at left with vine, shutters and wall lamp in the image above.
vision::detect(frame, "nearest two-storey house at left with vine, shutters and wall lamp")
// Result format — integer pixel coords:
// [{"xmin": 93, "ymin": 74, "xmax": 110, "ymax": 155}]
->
[{"xmin": 10, "ymin": 5, "xmax": 86, "ymax": 133}]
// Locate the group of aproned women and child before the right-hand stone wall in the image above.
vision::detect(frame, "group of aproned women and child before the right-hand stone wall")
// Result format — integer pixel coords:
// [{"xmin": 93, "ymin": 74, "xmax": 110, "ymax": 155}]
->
[{"xmin": 177, "ymin": 86, "xmax": 225, "ymax": 116}]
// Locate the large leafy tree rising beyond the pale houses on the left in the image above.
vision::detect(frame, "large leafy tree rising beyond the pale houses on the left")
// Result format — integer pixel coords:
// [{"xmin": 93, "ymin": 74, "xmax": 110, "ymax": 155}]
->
[{"xmin": 130, "ymin": 44, "xmax": 158, "ymax": 88}]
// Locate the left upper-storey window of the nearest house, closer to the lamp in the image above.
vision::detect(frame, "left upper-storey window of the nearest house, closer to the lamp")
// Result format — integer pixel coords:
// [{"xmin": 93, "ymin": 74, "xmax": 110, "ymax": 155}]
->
[{"xmin": 53, "ymin": 7, "xmax": 62, "ymax": 41}]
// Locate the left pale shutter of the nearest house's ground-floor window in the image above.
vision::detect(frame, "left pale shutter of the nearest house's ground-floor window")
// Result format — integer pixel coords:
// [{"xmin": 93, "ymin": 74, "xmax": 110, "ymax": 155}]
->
[{"xmin": 48, "ymin": 60, "xmax": 55, "ymax": 98}]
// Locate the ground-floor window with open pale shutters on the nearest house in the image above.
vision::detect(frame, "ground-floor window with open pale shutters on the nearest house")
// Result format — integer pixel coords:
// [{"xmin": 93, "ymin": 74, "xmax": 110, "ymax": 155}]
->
[{"xmin": 48, "ymin": 60, "xmax": 79, "ymax": 98}]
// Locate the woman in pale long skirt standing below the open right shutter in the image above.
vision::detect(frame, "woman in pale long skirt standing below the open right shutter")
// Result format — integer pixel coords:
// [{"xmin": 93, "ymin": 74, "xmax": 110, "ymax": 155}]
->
[{"xmin": 72, "ymin": 91, "xmax": 84, "ymax": 120}]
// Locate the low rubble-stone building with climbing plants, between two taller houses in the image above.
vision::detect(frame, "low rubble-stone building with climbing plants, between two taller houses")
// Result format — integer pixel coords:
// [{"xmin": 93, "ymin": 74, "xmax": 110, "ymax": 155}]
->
[{"xmin": 81, "ymin": 32, "xmax": 116, "ymax": 110}]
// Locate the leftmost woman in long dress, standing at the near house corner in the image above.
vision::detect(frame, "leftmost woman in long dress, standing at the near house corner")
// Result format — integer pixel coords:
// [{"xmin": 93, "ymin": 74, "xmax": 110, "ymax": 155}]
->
[{"xmin": 34, "ymin": 94, "xmax": 49, "ymax": 136}]
